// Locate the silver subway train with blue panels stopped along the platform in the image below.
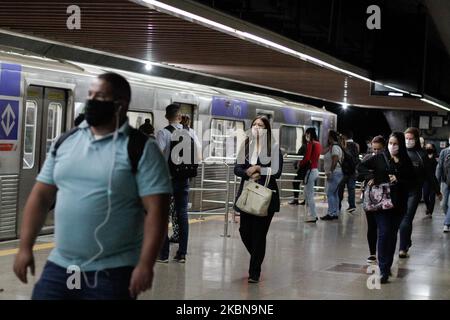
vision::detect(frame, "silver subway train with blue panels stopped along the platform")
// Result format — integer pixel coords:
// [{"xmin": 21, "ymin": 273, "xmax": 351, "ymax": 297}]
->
[{"xmin": 0, "ymin": 51, "xmax": 337, "ymax": 240}]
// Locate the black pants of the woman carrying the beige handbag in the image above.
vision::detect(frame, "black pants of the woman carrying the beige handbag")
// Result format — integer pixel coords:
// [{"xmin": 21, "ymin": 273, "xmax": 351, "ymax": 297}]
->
[{"xmin": 239, "ymin": 212, "xmax": 274, "ymax": 279}]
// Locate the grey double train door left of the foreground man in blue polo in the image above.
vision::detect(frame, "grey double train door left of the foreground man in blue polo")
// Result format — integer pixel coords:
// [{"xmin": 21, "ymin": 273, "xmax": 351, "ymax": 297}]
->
[{"xmin": 19, "ymin": 85, "xmax": 68, "ymax": 232}]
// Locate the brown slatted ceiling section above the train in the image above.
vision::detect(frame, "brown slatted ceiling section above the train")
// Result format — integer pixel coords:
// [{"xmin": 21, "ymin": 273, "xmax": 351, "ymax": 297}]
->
[{"xmin": 0, "ymin": 0, "xmax": 442, "ymax": 111}]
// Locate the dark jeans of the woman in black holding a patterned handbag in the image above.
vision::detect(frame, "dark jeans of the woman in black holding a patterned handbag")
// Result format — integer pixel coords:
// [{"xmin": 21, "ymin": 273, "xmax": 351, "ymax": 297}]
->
[{"xmin": 375, "ymin": 210, "xmax": 403, "ymax": 276}]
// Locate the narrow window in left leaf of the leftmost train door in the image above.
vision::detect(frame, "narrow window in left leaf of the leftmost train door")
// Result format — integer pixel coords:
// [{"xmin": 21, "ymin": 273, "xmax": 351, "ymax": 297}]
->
[{"xmin": 23, "ymin": 100, "xmax": 37, "ymax": 169}]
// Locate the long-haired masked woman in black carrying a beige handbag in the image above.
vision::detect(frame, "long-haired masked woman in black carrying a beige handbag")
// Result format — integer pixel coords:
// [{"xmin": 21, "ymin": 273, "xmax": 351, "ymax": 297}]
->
[{"xmin": 234, "ymin": 116, "xmax": 283, "ymax": 283}]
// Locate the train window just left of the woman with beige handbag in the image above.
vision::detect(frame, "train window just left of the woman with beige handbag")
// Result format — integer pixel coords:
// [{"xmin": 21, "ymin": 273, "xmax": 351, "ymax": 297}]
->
[{"xmin": 209, "ymin": 119, "xmax": 244, "ymax": 160}]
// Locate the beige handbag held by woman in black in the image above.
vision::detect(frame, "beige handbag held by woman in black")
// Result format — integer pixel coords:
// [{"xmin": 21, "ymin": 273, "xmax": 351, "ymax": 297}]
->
[{"xmin": 236, "ymin": 168, "xmax": 273, "ymax": 217}]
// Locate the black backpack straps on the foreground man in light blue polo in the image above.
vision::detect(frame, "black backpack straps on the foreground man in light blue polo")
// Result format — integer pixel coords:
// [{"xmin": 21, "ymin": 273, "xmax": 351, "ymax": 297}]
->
[{"xmin": 52, "ymin": 127, "xmax": 148, "ymax": 174}]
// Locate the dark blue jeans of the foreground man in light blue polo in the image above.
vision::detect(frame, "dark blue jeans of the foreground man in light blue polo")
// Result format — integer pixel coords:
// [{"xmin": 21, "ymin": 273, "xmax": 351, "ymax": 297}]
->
[{"xmin": 31, "ymin": 261, "xmax": 134, "ymax": 300}]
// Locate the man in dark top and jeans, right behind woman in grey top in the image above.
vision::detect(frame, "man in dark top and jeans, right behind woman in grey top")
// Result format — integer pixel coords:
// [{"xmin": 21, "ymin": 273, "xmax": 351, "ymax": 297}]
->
[{"xmin": 339, "ymin": 130, "xmax": 359, "ymax": 213}]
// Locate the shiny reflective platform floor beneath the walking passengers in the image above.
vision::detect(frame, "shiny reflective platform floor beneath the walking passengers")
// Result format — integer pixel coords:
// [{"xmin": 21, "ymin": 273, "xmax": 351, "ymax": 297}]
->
[{"xmin": 0, "ymin": 203, "xmax": 450, "ymax": 300}]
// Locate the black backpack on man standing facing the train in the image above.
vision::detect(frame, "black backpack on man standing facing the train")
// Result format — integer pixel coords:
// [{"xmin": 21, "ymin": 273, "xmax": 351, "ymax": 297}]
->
[{"xmin": 164, "ymin": 125, "xmax": 198, "ymax": 179}]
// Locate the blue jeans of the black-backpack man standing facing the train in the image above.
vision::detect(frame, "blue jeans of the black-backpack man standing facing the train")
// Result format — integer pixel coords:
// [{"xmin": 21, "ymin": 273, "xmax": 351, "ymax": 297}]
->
[{"xmin": 159, "ymin": 179, "xmax": 189, "ymax": 259}]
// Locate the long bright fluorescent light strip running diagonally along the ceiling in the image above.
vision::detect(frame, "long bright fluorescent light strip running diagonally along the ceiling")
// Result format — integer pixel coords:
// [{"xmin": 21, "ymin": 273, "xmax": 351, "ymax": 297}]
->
[{"xmin": 138, "ymin": 0, "xmax": 373, "ymax": 82}]
